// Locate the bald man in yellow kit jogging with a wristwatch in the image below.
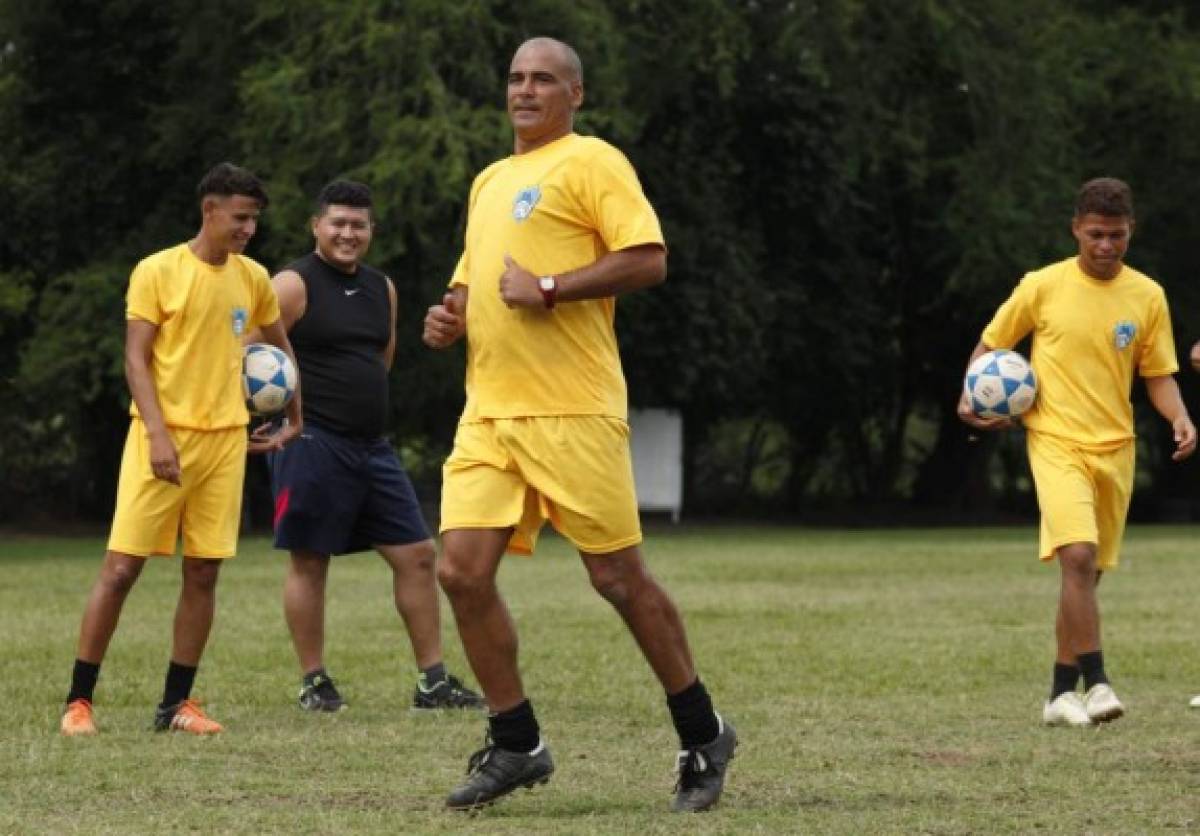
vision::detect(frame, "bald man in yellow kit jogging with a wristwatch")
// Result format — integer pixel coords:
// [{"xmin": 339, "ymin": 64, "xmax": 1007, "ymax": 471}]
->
[{"xmin": 424, "ymin": 38, "xmax": 737, "ymax": 811}]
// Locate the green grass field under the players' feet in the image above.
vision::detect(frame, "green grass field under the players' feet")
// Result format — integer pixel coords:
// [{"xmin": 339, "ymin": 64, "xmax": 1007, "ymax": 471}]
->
[{"xmin": 0, "ymin": 528, "xmax": 1200, "ymax": 834}]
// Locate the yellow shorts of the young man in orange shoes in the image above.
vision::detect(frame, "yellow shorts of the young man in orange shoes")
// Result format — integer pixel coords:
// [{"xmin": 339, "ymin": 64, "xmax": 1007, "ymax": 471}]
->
[{"xmin": 108, "ymin": 419, "xmax": 246, "ymax": 558}]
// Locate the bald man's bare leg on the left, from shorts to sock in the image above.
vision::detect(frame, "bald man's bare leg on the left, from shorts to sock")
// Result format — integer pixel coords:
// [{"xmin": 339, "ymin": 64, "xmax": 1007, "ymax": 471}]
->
[{"xmin": 437, "ymin": 529, "xmax": 524, "ymax": 712}]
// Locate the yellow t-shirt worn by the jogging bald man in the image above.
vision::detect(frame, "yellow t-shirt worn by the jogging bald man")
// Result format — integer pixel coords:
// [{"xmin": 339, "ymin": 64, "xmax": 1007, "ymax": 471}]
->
[{"xmin": 450, "ymin": 134, "xmax": 662, "ymax": 421}]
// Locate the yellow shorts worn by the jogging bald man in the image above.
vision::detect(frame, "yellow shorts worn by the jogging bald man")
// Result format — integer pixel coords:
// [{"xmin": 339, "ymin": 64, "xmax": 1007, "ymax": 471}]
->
[{"xmin": 442, "ymin": 415, "xmax": 642, "ymax": 554}]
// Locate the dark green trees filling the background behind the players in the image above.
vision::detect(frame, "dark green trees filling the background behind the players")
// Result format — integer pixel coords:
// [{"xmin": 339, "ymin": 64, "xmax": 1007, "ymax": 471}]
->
[{"xmin": 0, "ymin": 0, "xmax": 1200, "ymax": 517}]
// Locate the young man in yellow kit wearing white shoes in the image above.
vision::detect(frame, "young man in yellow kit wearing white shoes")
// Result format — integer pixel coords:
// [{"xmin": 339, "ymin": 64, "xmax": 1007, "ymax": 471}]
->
[{"xmin": 958, "ymin": 178, "xmax": 1196, "ymax": 726}]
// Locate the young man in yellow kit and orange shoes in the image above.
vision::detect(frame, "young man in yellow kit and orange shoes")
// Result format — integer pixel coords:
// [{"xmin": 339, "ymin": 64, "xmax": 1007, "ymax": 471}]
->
[{"xmin": 61, "ymin": 163, "xmax": 301, "ymax": 735}]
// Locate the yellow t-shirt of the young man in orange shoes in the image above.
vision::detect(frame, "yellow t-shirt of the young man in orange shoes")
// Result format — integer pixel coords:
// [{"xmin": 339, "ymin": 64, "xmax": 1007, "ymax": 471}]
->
[{"xmin": 125, "ymin": 243, "xmax": 280, "ymax": 429}]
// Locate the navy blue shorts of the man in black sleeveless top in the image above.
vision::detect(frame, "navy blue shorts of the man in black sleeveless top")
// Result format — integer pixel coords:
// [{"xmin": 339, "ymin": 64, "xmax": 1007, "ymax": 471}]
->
[{"xmin": 269, "ymin": 423, "xmax": 430, "ymax": 554}]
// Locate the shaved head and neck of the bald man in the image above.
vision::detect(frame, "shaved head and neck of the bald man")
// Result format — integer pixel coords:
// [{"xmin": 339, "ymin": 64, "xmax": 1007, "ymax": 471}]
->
[{"xmin": 508, "ymin": 38, "xmax": 583, "ymax": 154}]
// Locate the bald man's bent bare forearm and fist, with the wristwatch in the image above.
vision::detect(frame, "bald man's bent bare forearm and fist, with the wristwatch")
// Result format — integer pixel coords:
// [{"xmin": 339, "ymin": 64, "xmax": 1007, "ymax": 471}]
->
[{"xmin": 500, "ymin": 243, "xmax": 667, "ymax": 307}]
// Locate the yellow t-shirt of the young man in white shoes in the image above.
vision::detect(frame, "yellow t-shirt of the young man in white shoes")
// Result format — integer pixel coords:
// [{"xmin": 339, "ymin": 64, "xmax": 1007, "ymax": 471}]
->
[{"xmin": 983, "ymin": 258, "xmax": 1178, "ymax": 450}]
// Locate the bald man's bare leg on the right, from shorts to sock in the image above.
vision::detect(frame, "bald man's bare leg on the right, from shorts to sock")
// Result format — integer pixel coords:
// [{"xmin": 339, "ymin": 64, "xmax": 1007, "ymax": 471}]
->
[{"xmin": 580, "ymin": 546, "xmax": 696, "ymax": 693}]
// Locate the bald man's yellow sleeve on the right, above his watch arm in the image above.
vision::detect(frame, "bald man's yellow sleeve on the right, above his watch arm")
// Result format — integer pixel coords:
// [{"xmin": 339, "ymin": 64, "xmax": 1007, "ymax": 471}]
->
[{"xmin": 582, "ymin": 144, "xmax": 665, "ymax": 252}]
